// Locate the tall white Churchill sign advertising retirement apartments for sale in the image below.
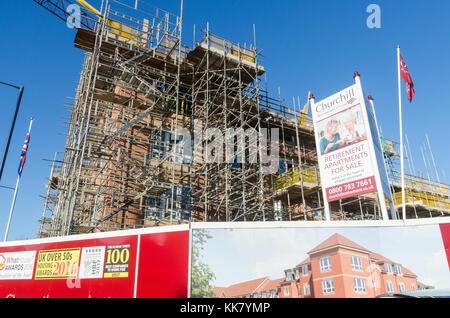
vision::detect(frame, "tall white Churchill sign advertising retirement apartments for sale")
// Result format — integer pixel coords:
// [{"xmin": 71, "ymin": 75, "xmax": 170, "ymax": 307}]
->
[{"xmin": 312, "ymin": 75, "xmax": 391, "ymax": 218}]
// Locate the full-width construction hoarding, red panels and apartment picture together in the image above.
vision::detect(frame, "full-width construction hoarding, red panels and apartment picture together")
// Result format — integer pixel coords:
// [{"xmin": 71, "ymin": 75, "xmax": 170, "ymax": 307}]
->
[{"xmin": 0, "ymin": 219, "xmax": 450, "ymax": 298}]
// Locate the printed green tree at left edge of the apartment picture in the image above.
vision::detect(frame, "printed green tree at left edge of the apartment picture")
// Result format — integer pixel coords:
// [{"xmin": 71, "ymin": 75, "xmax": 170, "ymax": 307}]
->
[{"xmin": 191, "ymin": 229, "xmax": 216, "ymax": 298}]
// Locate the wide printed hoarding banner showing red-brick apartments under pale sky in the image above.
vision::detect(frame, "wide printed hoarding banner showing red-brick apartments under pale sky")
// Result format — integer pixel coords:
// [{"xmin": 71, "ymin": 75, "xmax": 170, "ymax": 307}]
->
[{"xmin": 192, "ymin": 221, "xmax": 450, "ymax": 298}]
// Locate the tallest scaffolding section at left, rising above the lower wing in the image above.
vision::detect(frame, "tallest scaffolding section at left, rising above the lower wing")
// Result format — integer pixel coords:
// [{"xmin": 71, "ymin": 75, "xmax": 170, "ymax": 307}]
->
[{"xmin": 41, "ymin": 1, "xmax": 271, "ymax": 236}]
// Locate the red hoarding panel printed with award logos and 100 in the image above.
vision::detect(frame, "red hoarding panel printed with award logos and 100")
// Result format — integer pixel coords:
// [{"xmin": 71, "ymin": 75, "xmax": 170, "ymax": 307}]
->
[{"xmin": 0, "ymin": 235, "xmax": 138, "ymax": 298}]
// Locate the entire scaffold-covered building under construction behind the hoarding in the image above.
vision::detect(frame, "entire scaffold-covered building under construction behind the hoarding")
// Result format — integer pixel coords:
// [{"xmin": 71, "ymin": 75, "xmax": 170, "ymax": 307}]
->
[{"xmin": 35, "ymin": 0, "xmax": 450, "ymax": 237}]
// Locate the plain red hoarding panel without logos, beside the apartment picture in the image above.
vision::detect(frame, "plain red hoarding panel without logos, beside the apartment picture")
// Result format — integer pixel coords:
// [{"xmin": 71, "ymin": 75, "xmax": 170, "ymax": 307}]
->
[{"xmin": 137, "ymin": 231, "xmax": 189, "ymax": 298}]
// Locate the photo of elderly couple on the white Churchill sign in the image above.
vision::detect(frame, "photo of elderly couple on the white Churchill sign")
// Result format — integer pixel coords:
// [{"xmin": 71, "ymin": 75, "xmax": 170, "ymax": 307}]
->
[{"xmin": 318, "ymin": 106, "xmax": 367, "ymax": 155}]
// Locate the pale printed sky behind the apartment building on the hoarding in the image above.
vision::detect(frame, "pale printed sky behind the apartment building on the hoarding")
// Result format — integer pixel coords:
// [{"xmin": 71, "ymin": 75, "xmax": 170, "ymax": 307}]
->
[{"xmin": 202, "ymin": 225, "xmax": 450, "ymax": 289}]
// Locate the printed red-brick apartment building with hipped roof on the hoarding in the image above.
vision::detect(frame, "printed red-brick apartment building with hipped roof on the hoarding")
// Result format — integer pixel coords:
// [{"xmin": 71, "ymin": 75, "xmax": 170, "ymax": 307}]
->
[{"xmin": 215, "ymin": 233, "xmax": 424, "ymax": 298}]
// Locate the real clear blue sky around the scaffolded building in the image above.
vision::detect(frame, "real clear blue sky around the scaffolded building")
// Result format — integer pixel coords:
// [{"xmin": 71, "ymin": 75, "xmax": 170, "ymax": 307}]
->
[{"xmin": 0, "ymin": 0, "xmax": 450, "ymax": 240}]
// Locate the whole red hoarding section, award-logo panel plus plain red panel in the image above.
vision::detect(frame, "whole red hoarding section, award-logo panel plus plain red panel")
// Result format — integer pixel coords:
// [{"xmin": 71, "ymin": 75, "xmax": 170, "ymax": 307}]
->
[{"xmin": 0, "ymin": 226, "xmax": 189, "ymax": 298}]
